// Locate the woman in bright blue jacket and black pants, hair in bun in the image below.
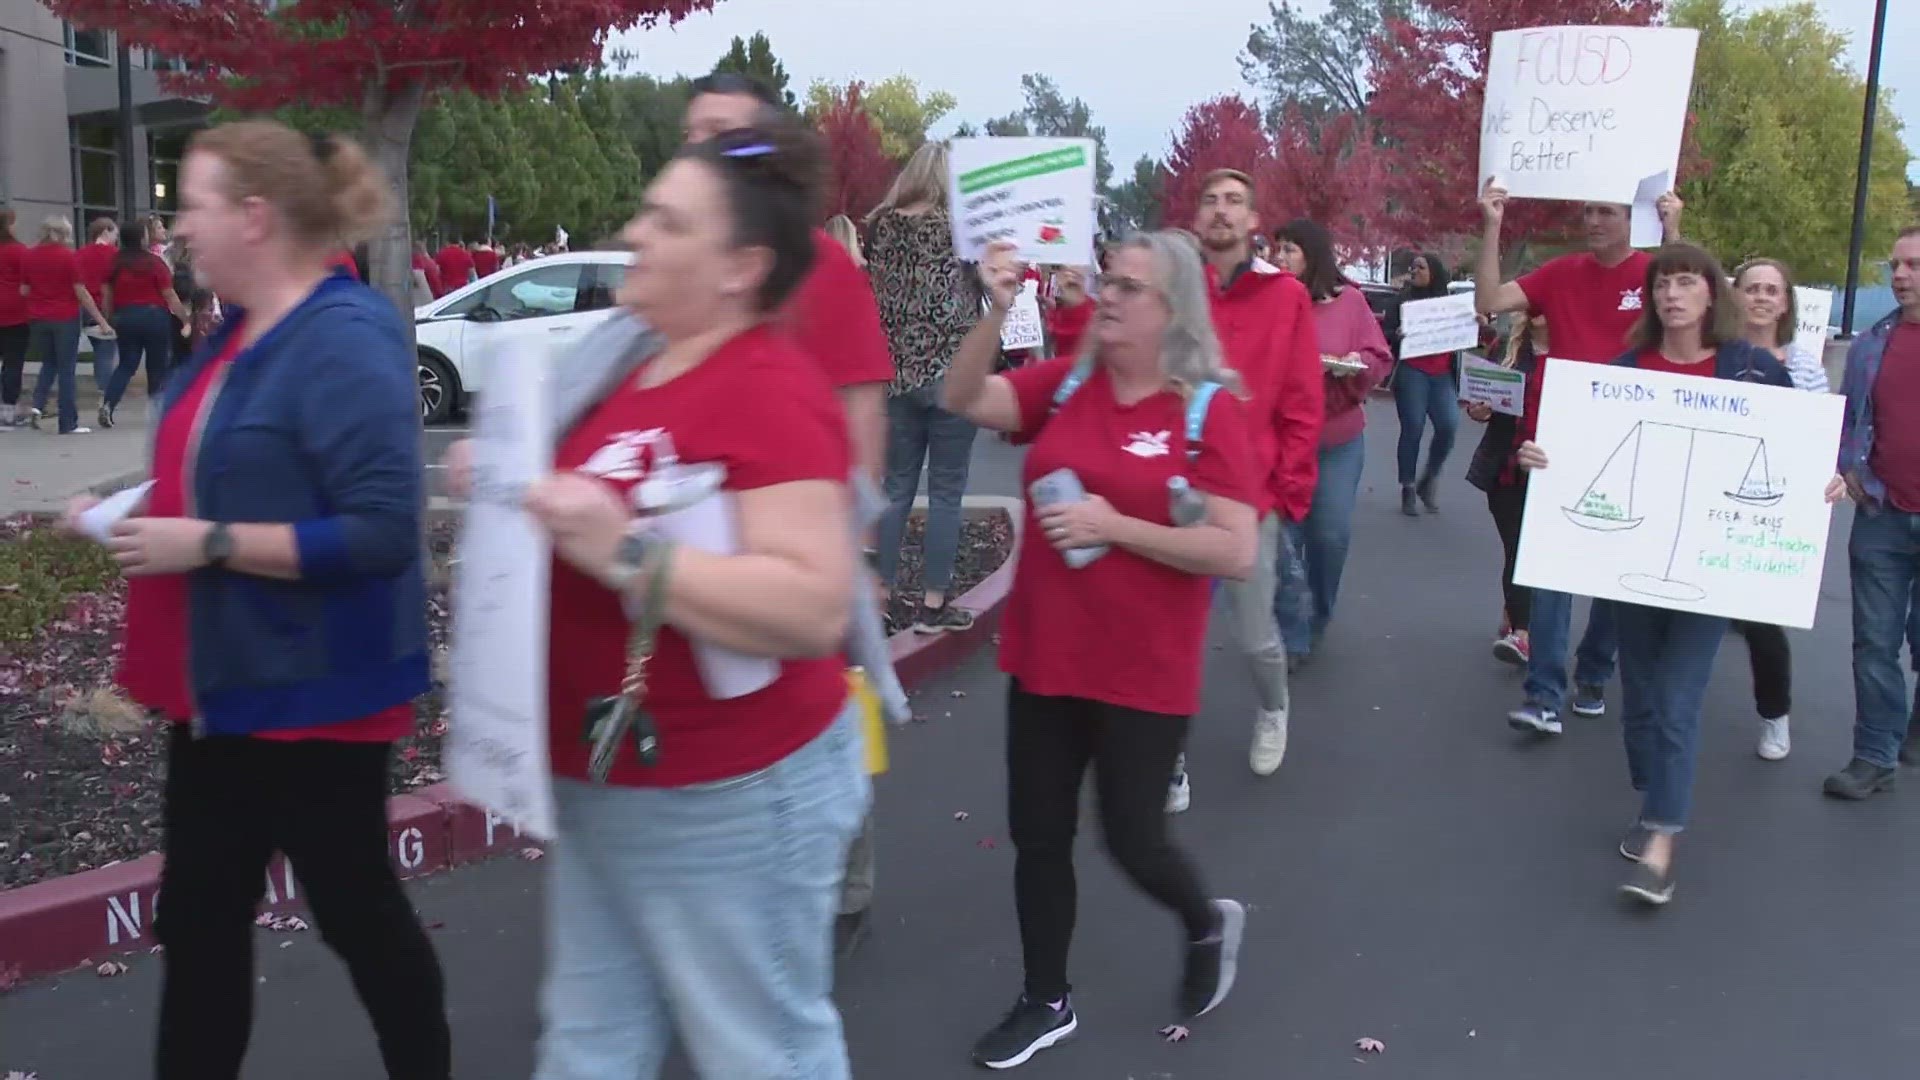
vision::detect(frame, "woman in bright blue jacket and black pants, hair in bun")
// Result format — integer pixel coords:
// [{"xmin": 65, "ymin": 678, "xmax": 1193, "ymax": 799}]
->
[{"xmin": 64, "ymin": 121, "xmax": 451, "ymax": 1080}]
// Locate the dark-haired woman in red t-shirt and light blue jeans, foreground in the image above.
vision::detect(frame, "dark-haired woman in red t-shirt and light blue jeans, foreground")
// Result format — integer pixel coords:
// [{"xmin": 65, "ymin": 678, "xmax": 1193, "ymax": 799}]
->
[{"xmin": 441, "ymin": 115, "xmax": 868, "ymax": 1080}]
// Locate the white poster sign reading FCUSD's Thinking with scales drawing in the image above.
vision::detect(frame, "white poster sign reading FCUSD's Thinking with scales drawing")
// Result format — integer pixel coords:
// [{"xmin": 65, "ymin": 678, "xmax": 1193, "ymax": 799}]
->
[{"xmin": 1513, "ymin": 359, "xmax": 1845, "ymax": 628}]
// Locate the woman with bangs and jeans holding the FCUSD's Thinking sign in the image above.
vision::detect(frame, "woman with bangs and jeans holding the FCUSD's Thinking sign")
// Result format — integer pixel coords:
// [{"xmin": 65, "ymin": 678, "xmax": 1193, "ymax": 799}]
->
[{"xmin": 1517, "ymin": 244, "xmax": 1843, "ymax": 905}]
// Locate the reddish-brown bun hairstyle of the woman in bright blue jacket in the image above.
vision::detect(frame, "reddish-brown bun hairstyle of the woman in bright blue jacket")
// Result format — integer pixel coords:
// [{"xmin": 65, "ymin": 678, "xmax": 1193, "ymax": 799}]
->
[{"xmin": 186, "ymin": 119, "xmax": 394, "ymax": 248}]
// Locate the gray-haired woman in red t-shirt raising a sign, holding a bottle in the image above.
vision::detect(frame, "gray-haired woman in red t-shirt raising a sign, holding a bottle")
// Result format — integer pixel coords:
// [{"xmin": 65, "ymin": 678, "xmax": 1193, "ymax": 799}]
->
[{"xmin": 945, "ymin": 233, "xmax": 1260, "ymax": 1068}]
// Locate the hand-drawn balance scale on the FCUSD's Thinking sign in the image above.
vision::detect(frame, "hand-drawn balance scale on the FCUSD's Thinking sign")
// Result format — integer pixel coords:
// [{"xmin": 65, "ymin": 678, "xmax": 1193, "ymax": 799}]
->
[{"xmin": 1561, "ymin": 421, "xmax": 1786, "ymax": 603}]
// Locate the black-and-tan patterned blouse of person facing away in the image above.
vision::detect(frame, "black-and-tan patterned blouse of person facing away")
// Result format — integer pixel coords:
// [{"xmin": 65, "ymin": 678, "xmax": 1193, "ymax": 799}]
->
[{"xmin": 866, "ymin": 209, "xmax": 981, "ymax": 396}]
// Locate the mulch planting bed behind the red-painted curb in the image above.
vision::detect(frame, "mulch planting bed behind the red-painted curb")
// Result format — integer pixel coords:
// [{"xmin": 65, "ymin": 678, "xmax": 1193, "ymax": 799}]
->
[{"xmin": 0, "ymin": 515, "xmax": 1012, "ymax": 890}]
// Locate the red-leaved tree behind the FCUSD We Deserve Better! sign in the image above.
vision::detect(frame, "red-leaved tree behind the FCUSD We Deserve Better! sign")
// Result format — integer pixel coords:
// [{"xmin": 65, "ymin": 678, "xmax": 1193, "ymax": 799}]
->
[{"xmin": 1367, "ymin": 0, "xmax": 1686, "ymax": 242}]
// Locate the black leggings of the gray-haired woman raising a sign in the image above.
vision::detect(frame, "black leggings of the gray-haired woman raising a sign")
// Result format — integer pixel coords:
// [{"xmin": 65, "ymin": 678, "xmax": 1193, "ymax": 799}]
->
[{"xmin": 1006, "ymin": 680, "xmax": 1213, "ymax": 1001}]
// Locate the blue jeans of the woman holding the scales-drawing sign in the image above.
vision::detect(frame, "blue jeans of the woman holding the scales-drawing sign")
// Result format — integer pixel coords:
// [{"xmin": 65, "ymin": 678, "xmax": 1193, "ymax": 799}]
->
[{"xmin": 1611, "ymin": 603, "xmax": 1726, "ymax": 832}]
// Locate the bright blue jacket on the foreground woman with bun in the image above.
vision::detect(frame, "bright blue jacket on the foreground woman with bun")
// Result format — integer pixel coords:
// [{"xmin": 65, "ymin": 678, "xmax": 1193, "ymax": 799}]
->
[{"xmin": 165, "ymin": 273, "xmax": 430, "ymax": 734}]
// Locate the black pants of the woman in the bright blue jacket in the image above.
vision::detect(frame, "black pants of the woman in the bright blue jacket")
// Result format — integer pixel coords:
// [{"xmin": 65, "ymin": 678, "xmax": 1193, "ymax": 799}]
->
[{"xmin": 156, "ymin": 726, "xmax": 453, "ymax": 1080}]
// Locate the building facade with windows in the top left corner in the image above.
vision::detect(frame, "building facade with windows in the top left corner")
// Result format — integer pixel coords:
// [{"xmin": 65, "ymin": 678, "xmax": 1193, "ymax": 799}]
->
[{"xmin": 0, "ymin": 0, "xmax": 209, "ymax": 242}]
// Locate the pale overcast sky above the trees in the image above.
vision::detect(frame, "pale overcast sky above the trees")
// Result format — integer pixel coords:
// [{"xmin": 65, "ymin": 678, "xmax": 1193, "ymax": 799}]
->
[{"xmin": 616, "ymin": 0, "xmax": 1920, "ymax": 179}]
